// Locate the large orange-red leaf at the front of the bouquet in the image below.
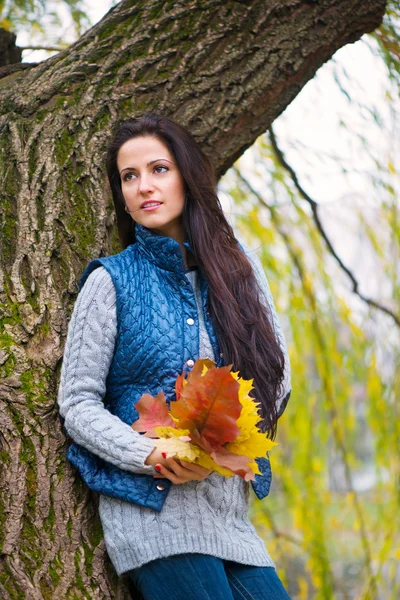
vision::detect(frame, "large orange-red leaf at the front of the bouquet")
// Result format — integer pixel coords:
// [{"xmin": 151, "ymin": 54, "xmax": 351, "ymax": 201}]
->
[{"xmin": 170, "ymin": 359, "xmax": 242, "ymax": 450}]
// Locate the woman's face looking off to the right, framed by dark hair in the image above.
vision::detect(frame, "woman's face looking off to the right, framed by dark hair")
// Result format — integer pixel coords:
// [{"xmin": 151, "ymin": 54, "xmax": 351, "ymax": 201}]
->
[{"xmin": 117, "ymin": 136, "xmax": 185, "ymax": 242}]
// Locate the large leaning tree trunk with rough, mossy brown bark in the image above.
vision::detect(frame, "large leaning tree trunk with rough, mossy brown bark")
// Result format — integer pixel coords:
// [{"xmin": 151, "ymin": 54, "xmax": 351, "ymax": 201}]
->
[{"xmin": 0, "ymin": 0, "xmax": 385, "ymax": 600}]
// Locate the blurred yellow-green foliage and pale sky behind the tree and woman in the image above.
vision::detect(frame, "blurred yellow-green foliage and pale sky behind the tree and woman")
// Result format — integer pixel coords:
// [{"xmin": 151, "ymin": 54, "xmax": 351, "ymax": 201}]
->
[{"xmin": 0, "ymin": 0, "xmax": 400, "ymax": 600}]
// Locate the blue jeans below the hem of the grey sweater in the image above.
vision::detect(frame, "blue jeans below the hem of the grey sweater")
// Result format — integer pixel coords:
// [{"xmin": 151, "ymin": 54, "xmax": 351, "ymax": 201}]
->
[{"xmin": 126, "ymin": 554, "xmax": 290, "ymax": 600}]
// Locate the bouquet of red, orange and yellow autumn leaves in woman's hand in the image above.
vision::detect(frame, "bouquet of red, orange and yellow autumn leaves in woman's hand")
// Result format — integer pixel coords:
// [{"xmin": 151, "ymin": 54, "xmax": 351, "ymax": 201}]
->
[{"xmin": 132, "ymin": 359, "xmax": 277, "ymax": 481}]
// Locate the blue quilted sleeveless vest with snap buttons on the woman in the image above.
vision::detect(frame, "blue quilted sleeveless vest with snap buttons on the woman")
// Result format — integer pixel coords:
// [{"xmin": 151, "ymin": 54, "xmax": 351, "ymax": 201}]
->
[{"xmin": 66, "ymin": 224, "xmax": 271, "ymax": 511}]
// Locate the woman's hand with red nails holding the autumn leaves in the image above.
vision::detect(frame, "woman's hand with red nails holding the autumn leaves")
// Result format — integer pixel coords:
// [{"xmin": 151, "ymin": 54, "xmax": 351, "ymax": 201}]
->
[{"xmin": 145, "ymin": 448, "xmax": 212, "ymax": 484}]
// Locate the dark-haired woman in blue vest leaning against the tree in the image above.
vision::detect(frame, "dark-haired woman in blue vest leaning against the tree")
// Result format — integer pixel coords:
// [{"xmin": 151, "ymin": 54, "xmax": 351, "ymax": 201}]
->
[{"xmin": 58, "ymin": 113, "xmax": 290, "ymax": 600}]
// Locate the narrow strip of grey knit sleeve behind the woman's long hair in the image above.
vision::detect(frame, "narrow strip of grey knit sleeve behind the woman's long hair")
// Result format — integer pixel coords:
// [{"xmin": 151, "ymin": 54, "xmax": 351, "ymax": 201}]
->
[{"xmin": 241, "ymin": 243, "xmax": 292, "ymax": 417}]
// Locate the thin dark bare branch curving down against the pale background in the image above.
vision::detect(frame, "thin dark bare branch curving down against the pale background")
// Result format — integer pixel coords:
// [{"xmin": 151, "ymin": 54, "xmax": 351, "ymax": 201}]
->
[{"xmin": 268, "ymin": 126, "xmax": 400, "ymax": 327}]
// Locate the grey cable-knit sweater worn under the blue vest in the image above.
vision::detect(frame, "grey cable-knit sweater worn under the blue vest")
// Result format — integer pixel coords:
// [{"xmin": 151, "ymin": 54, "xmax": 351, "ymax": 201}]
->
[{"xmin": 58, "ymin": 248, "xmax": 291, "ymax": 575}]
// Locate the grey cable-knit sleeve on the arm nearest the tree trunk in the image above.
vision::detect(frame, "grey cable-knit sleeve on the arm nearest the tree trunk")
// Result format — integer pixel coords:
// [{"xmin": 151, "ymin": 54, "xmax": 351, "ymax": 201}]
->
[{"xmin": 58, "ymin": 267, "xmax": 156, "ymax": 475}]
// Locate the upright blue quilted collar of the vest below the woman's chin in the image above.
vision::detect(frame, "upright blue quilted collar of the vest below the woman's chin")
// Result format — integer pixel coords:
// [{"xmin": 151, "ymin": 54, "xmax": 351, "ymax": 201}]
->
[{"xmin": 135, "ymin": 223, "xmax": 196, "ymax": 273}]
